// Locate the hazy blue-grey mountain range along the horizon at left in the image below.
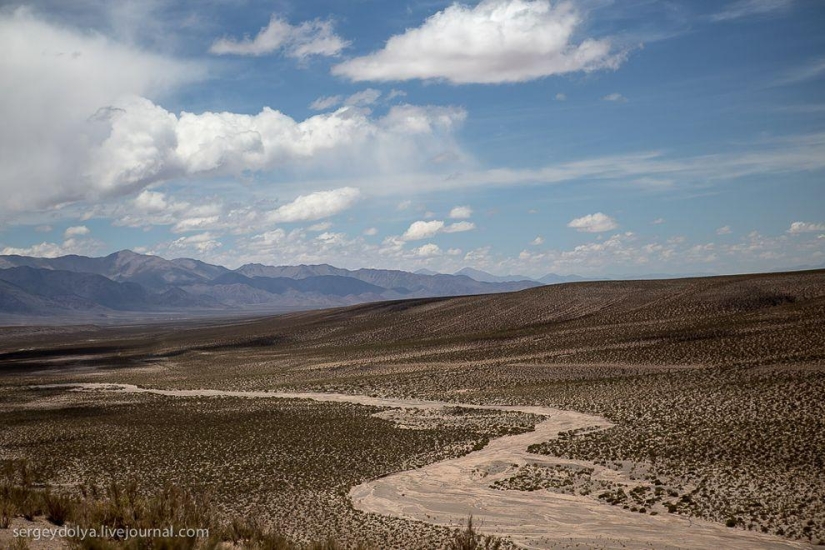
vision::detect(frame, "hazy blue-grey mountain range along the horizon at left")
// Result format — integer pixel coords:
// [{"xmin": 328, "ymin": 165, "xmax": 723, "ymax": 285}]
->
[{"xmin": 0, "ymin": 250, "xmax": 539, "ymax": 316}]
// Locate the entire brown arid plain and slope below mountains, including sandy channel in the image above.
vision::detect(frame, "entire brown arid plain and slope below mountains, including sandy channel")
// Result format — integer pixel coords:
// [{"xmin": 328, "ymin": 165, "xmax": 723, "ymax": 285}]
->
[{"xmin": 0, "ymin": 271, "xmax": 825, "ymax": 548}]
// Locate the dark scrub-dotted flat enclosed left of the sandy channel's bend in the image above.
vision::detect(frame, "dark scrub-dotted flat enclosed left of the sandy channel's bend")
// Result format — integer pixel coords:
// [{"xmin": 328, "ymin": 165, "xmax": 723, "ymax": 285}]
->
[{"xmin": 0, "ymin": 388, "xmax": 538, "ymax": 549}]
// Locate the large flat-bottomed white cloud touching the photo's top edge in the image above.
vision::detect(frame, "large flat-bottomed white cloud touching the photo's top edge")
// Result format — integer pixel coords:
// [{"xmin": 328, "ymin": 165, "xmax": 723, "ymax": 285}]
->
[{"xmin": 333, "ymin": 0, "xmax": 624, "ymax": 84}]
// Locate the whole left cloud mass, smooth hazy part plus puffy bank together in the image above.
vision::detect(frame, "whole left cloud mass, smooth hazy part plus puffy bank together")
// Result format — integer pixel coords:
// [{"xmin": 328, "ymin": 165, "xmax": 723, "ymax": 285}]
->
[{"xmin": 0, "ymin": 9, "xmax": 466, "ymax": 219}]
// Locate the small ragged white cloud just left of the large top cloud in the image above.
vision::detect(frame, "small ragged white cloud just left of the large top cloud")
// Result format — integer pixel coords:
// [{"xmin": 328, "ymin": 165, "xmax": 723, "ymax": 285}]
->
[{"xmin": 209, "ymin": 15, "xmax": 349, "ymax": 60}]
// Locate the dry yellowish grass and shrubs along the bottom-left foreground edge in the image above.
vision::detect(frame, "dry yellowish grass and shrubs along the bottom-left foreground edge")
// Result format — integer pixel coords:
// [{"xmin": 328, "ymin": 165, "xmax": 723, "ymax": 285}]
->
[{"xmin": 0, "ymin": 461, "xmax": 504, "ymax": 550}]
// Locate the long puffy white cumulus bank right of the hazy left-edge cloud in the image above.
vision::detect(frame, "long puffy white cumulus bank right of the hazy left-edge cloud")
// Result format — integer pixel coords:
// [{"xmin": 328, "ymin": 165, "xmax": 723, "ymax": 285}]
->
[{"xmin": 78, "ymin": 97, "xmax": 466, "ymax": 205}]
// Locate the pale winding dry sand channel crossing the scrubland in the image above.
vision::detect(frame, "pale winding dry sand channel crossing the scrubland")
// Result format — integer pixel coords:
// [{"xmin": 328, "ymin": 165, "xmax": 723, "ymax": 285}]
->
[{"xmin": 40, "ymin": 383, "xmax": 812, "ymax": 550}]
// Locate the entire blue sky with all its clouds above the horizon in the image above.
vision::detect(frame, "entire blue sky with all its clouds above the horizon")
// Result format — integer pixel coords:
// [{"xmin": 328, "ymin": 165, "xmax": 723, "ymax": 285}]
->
[{"xmin": 0, "ymin": 0, "xmax": 825, "ymax": 277}]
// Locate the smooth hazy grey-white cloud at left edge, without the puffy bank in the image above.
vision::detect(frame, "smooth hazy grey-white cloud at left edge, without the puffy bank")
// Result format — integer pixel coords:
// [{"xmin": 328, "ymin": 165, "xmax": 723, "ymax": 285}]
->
[{"xmin": 0, "ymin": 8, "xmax": 205, "ymax": 216}]
